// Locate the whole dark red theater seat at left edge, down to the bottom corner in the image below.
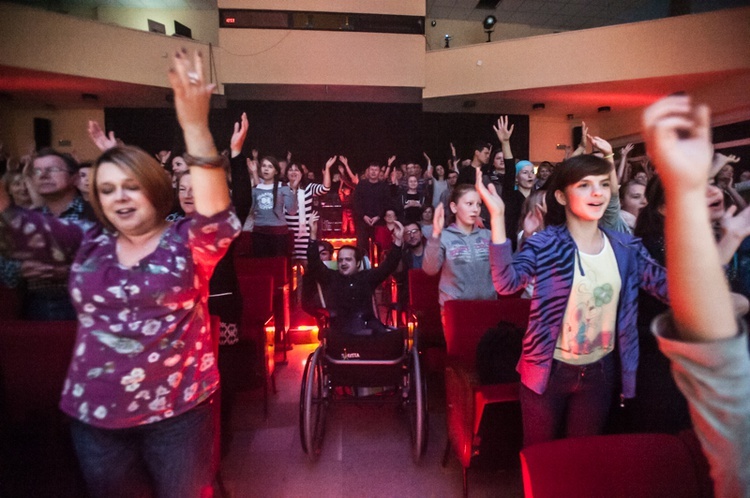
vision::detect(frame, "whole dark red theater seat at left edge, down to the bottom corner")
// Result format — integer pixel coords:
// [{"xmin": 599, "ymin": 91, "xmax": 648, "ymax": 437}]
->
[{"xmin": 0, "ymin": 320, "xmax": 85, "ymax": 496}]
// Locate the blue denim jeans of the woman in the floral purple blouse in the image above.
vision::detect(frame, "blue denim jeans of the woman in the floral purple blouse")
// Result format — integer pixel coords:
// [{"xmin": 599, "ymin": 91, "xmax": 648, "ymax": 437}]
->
[{"xmin": 71, "ymin": 396, "xmax": 218, "ymax": 498}]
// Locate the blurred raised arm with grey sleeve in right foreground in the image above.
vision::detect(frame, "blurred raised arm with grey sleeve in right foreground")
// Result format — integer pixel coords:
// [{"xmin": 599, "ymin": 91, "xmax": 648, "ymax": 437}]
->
[{"xmin": 643, "ymin": 96, "xmax": 750, "ymax": 497}]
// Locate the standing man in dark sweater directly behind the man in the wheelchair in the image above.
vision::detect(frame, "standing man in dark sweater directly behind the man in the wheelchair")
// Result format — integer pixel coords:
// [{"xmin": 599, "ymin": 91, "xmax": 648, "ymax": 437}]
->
[{"xmin": 352, "ymin": 163, "xmax": 391, "ymax": 254}]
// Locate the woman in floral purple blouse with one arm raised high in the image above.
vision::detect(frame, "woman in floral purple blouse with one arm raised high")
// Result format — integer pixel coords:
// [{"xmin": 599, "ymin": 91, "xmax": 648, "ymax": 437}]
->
[{"xmin": 0, "ymin": 51, "xmax": 240, "ymax": 497}]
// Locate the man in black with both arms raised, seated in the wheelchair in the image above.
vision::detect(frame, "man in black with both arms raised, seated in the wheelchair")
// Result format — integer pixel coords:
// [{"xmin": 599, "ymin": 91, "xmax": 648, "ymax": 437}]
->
[{"xmin": 305, "ymin": 219, "xmax": 404, "ymax": 334}]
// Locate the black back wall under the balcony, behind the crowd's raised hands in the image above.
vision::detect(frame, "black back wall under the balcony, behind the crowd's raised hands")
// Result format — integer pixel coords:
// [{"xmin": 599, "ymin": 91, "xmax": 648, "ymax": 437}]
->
[{"xmin": 105, "ymin": 101, "xmax": 529, "ymax": 171}]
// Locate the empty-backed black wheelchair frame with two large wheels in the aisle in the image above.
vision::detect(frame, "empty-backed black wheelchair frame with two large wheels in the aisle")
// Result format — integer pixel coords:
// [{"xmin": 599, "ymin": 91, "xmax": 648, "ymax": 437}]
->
[{"xmin": 299, "ymin": 319, "xmax": 428, "ymax": 463}]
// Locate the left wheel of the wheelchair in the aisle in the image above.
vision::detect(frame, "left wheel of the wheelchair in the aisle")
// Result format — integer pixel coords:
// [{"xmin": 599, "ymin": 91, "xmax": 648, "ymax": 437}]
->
[{"xmin": 299, "ymin": 346, "xmax": 328, "ymax": 462}]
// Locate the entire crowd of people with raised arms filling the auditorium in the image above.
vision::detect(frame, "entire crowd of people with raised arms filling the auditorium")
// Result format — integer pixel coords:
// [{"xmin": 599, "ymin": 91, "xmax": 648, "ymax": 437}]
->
[{"xmin": 0, "ymin": 48, "xmax": 750, "ymax": 496}]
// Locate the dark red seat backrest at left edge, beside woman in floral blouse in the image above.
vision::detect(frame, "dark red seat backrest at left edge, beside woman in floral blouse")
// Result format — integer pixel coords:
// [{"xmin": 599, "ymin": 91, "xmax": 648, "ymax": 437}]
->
[{"xmin": 0, "ymin": 320, "xmax": 78, "ymax": 422}]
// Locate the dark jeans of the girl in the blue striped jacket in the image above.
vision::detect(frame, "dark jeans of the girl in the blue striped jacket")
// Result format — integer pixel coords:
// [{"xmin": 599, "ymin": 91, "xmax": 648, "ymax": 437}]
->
[{"xmin": 520, "ymin": 353, "xmax": 617, "ymax": 447}]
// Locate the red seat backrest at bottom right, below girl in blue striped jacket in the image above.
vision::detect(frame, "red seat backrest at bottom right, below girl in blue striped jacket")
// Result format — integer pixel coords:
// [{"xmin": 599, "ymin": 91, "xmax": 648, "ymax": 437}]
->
[{"xmin": 521, "ymin": 434, "xmax": 706, "ymax": 498}]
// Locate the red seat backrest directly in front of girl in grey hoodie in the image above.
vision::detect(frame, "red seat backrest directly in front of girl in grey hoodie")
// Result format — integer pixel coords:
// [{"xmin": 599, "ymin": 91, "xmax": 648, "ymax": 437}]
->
[{"xmin": 443, "ymin": 297, "xmax": 531, "ymax": 371}]
